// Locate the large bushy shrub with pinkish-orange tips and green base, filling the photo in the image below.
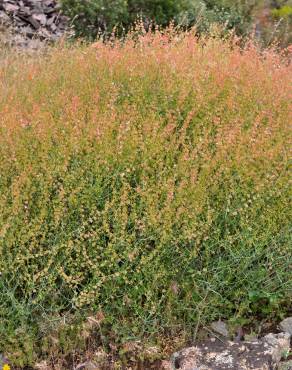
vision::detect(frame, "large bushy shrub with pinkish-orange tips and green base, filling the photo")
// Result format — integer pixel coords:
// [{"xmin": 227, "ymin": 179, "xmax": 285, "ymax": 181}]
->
[{"xmin": 0, "ymin": 31, "xmax": 292, "ymax": 368}]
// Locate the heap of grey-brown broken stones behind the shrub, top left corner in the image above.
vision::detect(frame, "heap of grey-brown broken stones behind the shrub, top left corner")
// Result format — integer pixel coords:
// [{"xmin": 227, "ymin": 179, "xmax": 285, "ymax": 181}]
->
[{"xmin": 0, "ymin": 0, "xmax": 69, "ymax": 49}]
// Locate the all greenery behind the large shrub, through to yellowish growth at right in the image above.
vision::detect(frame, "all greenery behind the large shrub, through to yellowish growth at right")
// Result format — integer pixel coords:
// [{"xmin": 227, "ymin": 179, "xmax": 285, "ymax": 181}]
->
[{"xmin": 61, "ymin": 0, "xmax": 292, "ymax": 45}]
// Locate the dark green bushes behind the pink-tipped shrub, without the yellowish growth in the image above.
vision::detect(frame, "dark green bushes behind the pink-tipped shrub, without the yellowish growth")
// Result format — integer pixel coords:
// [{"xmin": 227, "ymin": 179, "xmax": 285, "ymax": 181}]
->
[{"xmin": 61, "ymin": 0, "xmax": 255, "ymax": 38}]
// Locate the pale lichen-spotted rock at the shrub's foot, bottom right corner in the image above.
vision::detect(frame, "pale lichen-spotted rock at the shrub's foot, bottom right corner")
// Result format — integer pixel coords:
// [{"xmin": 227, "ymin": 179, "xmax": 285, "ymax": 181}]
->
[{"xmin": 166, "ymin": 317, "xmax": 292, "ymax": 370}]
